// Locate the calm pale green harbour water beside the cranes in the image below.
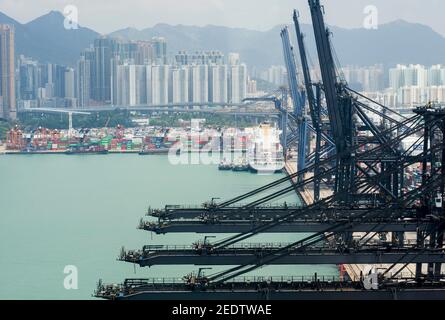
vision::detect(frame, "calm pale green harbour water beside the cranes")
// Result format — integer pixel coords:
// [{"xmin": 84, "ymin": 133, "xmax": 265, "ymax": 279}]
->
[{"xmin": 0, "ymin": 155, "xmax": 337, "ymax": 299}]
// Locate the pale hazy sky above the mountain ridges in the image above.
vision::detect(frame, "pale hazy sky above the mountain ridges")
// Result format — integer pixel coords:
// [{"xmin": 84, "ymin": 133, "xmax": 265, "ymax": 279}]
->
[{"xmin": 0, "ymin": 0, "xmax": 445, "ymax": 35}]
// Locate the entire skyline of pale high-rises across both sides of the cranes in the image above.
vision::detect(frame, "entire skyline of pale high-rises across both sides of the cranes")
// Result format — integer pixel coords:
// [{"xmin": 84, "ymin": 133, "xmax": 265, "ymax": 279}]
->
[{"xmin": 13, "ymin": 26, "xmax": 445, "ymax": 108}]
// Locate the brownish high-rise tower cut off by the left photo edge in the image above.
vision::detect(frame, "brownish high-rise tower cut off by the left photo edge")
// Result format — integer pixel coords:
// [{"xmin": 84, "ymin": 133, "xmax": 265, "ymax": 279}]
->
[{"xmin": 0, "ymin": 24, "xmax": 17, "ymax": 120}]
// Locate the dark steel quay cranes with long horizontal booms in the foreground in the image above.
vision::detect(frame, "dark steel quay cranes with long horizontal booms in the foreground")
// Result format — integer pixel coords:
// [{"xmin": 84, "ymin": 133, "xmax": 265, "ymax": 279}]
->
[{"xmin": 95, "ymin": 0, "xmax": 445, "ymax": 300}]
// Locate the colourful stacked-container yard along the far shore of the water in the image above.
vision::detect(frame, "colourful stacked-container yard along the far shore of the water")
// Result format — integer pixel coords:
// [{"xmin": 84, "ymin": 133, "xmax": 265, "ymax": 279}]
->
[{"xmin": 2, "ymin": 125, "xmax": 264, "ymax": 156}]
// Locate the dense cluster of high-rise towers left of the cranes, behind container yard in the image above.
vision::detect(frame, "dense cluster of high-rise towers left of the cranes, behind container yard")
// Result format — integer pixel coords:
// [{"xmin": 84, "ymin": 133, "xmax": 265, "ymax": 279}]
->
[{"xmin": 17, "ymin": 37, "xmax": 250, "ymax": 108}]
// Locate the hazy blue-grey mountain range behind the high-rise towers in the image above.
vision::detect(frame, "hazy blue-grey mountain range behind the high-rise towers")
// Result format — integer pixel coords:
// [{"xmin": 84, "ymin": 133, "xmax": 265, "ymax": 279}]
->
[{"xmin": 0, "ymin": 11, "xmax": 445, "ymax": 68}]
